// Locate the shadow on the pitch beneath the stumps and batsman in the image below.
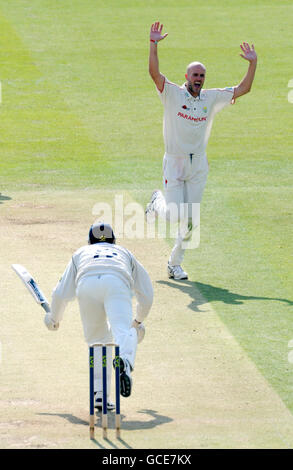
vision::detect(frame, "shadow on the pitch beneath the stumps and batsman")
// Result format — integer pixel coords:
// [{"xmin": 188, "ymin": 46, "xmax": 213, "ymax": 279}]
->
[{"xmin": 38, "ymin": 409, "xmax": 173, "ymax": 449}]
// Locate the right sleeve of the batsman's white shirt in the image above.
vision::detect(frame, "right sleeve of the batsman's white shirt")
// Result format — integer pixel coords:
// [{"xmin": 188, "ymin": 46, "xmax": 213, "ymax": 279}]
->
[{"xmin": 132, "ymin": 257, "xmax": 154, "ymax": 322}]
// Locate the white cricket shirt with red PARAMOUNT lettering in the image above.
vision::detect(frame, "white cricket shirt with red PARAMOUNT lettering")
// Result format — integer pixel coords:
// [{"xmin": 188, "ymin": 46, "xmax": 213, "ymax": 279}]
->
[{"xmin": 157, "ymin": 77, "xmax": 234, "ymax": 157}]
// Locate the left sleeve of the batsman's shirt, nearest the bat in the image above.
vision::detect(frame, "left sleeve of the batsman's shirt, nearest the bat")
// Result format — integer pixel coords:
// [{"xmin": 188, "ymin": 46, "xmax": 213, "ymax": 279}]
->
[{"xmin": 51, "ymin": 260, "xmax": 76, "ymax": 322}]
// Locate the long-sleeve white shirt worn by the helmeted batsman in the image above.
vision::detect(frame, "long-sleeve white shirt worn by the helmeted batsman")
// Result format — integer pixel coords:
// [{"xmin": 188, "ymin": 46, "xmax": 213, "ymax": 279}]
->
[{"xmin": 51, "ymin": 242, "xmax": 153, "ymax": 322}]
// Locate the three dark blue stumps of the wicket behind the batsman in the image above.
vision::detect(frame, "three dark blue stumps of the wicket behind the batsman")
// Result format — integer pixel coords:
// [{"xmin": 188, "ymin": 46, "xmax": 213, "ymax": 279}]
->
[{"xmin": 89, "ymin": 343, "xmax": 121, "ymax": 439}]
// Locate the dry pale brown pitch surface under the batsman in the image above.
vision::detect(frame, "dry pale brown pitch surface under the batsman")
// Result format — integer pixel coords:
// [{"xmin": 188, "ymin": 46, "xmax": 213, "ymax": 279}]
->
[{"xmin": 0, "ymin": 191, "xmax": 293, "ymax": 449}]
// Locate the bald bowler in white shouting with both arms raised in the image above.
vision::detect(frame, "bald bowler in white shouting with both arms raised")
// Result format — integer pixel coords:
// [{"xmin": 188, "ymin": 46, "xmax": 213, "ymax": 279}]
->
[{"xmin": 146, "ymin": 22, "xmax": 257, "ymax": 280}]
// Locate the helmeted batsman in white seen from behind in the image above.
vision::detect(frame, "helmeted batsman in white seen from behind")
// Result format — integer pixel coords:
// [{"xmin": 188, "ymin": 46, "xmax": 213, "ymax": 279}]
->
[{"xmin": 45, "ymin": 223, "xmax": 153, "ymax": 409}]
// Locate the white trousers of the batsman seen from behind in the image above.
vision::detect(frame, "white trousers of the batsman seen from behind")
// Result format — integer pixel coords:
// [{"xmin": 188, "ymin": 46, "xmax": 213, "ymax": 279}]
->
[{"xmin": 76, "ymin": 274, "xmax": 137, "ymax": 397}]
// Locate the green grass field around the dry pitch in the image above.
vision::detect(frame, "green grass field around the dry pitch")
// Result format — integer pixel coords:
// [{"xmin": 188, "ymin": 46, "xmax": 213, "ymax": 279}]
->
[{"xmin": 0, "ymin": 0, "xmax": 293, "ymax": 446}]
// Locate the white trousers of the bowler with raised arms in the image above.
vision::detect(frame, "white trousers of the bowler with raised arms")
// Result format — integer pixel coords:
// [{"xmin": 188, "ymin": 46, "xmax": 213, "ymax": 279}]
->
[{"xmin": 154, "ymin": 154, "xmax": 209, "ymax": 266}]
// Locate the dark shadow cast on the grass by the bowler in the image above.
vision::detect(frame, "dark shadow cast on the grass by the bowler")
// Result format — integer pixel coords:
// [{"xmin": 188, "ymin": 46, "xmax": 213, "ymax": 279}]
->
[{"xmin": 157, "ymin": 280, "xmax": 293, "ymax": 312}]
